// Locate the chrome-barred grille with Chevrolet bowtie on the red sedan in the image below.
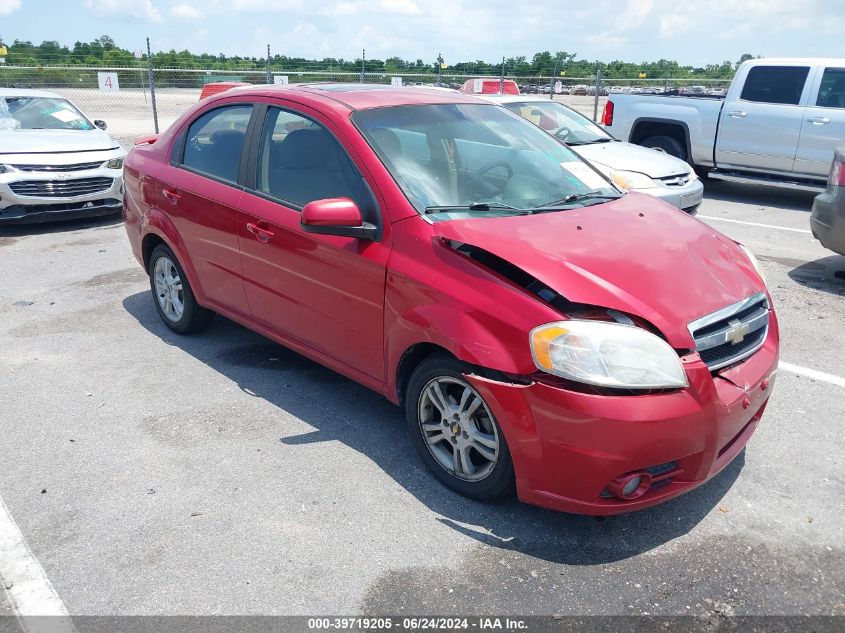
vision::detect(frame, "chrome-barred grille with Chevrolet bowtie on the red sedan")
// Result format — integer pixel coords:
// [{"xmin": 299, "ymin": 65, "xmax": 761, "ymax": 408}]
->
[{"xmin": 689, "ymin": 292, "xmax": 771, "ymax": 371}]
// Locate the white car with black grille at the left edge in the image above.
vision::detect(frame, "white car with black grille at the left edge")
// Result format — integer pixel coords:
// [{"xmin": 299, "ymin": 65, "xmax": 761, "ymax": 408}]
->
[{"xmin": 0, "ymin": 88, "xmax": 126, "ymax": 225}]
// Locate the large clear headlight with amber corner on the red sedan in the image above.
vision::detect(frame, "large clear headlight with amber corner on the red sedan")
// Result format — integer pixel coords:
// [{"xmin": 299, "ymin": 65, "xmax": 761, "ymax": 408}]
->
[{"xmin": 530, "ymin": 320, "xmax": 688, "ymax": 389}]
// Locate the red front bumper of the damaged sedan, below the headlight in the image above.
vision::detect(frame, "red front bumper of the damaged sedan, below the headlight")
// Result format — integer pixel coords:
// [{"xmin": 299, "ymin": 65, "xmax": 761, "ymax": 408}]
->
[{"xmin": 467, "ymin": 316, "xmax": 778, "ymax": 515}]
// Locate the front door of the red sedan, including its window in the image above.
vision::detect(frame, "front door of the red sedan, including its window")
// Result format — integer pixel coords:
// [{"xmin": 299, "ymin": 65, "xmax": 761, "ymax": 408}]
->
[{"xmin": 234, "ymin": 106, "xmax": 390, "ymax": 381}]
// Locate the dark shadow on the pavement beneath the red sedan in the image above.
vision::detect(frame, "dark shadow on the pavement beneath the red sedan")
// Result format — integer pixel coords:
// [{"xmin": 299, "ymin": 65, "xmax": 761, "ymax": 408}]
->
[{"xmin": 123, "ymin": 292, "xmax": 745, "ymax": 565}]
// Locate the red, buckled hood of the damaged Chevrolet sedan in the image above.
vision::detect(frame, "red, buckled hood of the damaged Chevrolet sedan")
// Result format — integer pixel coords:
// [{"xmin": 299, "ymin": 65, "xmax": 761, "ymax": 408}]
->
[{"xmin": 433, "ymin": 193, "xmax": 765, "ymax": 349}]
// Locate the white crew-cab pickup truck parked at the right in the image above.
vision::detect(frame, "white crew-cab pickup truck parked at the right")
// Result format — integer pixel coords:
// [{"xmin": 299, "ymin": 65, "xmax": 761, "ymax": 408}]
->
[{"xmin": 601, "ymin": 59, "xmax": 845, "ymax": 191}]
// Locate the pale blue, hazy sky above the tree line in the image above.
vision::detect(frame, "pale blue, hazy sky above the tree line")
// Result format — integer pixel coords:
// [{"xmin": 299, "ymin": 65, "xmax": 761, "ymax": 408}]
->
[{"xmin": 0, "ymin": 0, "xmax": 845, "ymax": 66}]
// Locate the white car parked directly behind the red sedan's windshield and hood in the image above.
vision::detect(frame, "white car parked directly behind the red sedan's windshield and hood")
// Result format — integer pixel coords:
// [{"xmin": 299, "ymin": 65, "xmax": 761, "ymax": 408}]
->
[{"xmin": 479, "ymin": 95, "xmax": 704, "ymax": 215}]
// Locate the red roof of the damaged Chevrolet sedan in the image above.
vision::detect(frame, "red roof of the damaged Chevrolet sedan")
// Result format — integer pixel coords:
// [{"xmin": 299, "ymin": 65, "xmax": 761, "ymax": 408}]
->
[{"xmin": 211, "ymin": 83, "xmax": 480, "ymax": 110}]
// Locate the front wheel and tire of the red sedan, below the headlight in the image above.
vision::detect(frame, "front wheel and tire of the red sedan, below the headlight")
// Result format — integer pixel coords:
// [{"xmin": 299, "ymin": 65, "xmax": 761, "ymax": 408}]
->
[{"xmin": 405, "ymin": 354, "xmax": 515, "ymax": 500}]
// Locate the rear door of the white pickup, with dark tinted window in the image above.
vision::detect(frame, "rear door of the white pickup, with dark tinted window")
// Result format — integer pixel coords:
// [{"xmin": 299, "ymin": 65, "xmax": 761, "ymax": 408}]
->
[{"xmin": 716, "ymin": 64, "xmax": 810, "ymax": 172}]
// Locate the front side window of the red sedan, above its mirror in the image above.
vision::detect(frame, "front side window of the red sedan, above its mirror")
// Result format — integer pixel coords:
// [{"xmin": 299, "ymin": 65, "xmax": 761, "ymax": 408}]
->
[{"xmin": 256, "ymin": 108, "xmax": 366, "ymax": 207}]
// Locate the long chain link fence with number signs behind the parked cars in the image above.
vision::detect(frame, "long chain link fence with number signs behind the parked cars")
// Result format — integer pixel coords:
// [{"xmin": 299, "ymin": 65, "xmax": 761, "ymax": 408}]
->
[{"xmin": 0, "ymin": 60, "xmax": 730, "ymax": 145}]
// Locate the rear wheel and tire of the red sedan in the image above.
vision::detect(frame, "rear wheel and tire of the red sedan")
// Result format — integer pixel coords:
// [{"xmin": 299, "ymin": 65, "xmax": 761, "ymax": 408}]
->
[{"xmin": 148, "ymin": 244, "xmax": 214, "ymax": 334}]
